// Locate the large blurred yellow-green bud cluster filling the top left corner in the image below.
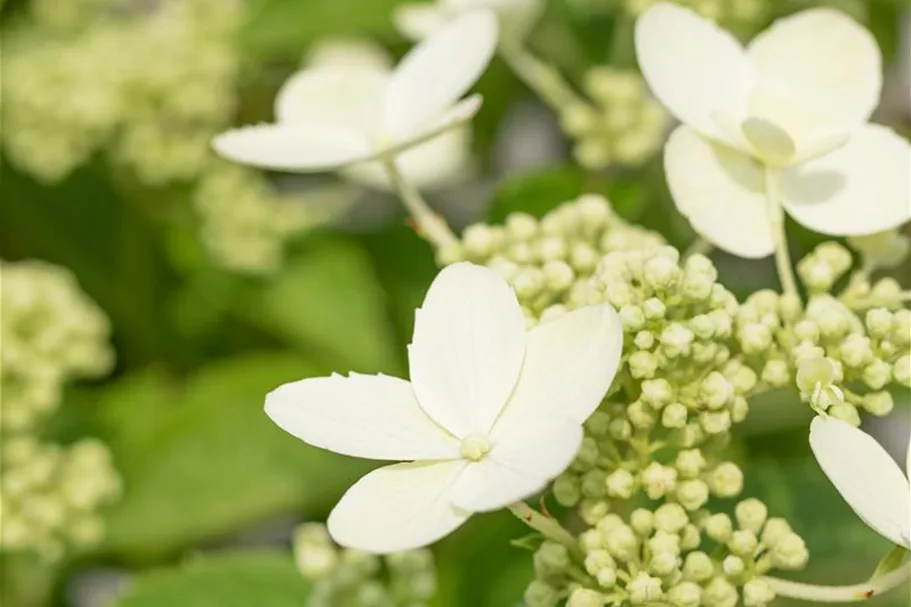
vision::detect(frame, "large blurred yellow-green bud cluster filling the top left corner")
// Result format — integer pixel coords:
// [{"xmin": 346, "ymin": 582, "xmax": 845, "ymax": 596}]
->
[{"xmin": 2, "ymin": 0, "xmax": 243, "ymax": 185}]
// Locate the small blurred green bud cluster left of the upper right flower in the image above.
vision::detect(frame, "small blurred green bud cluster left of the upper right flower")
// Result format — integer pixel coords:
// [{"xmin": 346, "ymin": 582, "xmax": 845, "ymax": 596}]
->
[{"xmin": 560, "ymin": 66, "xmax": 668, "ymax": 170}]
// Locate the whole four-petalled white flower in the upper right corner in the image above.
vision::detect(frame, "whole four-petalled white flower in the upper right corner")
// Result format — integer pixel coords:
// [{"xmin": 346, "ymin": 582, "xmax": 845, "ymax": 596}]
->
[{"xmin": 636, "ymin": 3, "xmax": 911, "ymax": 257}]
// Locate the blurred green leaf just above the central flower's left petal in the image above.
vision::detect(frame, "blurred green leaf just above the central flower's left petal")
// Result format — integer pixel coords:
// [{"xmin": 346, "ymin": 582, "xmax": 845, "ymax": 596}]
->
[{"xmin": 249, "ymin": 237, "xmax": 403, "ymax": 373}]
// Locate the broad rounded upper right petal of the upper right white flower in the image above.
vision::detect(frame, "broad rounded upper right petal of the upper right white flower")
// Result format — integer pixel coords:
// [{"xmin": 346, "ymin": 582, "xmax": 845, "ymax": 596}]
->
[{"xmin": 747, "ymin": 8, "xmax": 882, "ymax": 134}]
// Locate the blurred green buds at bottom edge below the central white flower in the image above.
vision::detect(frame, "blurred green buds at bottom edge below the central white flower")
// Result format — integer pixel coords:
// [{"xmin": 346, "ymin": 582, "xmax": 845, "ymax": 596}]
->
[{"xmin": 294, "ymin": 523, "xmax": 437, "ymax": 607}]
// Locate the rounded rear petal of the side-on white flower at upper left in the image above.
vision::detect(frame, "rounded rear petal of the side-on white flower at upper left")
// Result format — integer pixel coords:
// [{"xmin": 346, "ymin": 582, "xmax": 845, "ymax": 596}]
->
[{"xmin": 275, "ymin": 63, "xmax": 390, "ymax": 131}]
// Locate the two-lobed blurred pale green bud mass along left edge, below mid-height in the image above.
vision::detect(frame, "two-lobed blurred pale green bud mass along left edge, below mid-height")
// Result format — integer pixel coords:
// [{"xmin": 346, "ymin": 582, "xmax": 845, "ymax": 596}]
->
[{"xmin": 0, "ymin": 261, "xmax": 120, "ymax": 559}]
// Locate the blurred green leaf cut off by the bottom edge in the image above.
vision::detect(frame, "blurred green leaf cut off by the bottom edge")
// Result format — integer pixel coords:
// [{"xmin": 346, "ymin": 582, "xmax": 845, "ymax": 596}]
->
[{"xmin": 114, "ymin": 552, "xmax": 310, "ymax": 607}]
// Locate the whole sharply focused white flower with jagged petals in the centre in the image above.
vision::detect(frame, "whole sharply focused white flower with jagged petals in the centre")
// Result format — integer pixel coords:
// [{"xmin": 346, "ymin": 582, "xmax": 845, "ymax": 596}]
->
[{"xmin": 266, "ymin": 263, "xmax": 623, "ymax": 553}]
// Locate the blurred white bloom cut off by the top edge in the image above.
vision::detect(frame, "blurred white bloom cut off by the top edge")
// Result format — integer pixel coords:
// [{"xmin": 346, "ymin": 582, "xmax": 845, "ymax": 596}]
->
[{"xmin": 393, "ymin": 0, "xmax": 545, "ymax": 40}]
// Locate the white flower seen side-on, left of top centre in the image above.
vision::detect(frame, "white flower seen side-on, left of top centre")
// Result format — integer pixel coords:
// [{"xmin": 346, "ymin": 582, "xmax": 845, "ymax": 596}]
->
[{"xmin": 214, "ymin": 11, "xmax": 497, "ymax": 188}]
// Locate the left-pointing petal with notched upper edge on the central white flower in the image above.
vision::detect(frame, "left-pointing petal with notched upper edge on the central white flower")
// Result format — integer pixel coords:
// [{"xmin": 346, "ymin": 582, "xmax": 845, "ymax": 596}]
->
[{"xmin": 266, "ymin": 374, "xmax": 459, "ymax": 460}]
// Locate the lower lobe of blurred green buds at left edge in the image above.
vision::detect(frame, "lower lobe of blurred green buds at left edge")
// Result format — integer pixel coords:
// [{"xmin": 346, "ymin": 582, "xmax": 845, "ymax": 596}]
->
[{"xmin": 0, "ymin": 434, "xmax": 121, "ymax": 560}]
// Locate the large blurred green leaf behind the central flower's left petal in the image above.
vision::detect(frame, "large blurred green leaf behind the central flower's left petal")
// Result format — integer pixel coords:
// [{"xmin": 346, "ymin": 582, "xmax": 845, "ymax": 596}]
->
[{"xmin": 95, "ymin": 353, "xmax": 366, "ymax": 561}]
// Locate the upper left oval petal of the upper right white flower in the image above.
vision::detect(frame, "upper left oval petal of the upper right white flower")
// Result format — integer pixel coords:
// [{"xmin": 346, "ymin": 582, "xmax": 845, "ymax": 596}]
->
[{"xmin": 636, "ymin": 2, "xmax": 754, "ymax": 141}]
